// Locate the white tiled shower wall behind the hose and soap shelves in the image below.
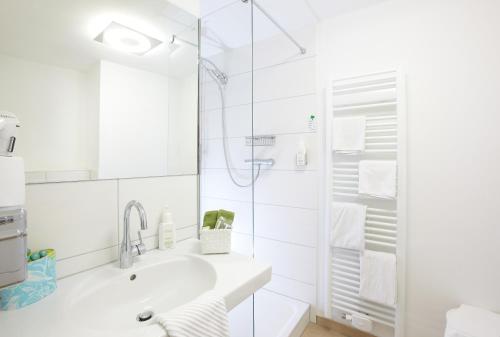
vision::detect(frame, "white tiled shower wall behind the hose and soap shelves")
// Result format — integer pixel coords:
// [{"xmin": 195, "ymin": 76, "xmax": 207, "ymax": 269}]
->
[{"xmin": 200, "ymin": 22, "xmax": 320, "ymax": 310}]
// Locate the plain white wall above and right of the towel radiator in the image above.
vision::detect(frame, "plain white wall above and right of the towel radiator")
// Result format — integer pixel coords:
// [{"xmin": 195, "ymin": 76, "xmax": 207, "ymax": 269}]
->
[{"xmin": 318, "ymin": 0, "xmax": 500, "ymax": 337}]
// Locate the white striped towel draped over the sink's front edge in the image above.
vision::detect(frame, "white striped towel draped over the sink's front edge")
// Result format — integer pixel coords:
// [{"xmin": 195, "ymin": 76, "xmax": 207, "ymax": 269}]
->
[{"xmin": 156, "ymin": 292, "xmax": 229, "ymax": 337}]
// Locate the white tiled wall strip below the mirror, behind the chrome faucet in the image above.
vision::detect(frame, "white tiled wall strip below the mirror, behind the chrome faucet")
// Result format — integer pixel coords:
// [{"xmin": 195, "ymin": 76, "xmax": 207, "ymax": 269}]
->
[{"xmin": 26, "ymin": 175, "xmax": 198, "ymax": 278}]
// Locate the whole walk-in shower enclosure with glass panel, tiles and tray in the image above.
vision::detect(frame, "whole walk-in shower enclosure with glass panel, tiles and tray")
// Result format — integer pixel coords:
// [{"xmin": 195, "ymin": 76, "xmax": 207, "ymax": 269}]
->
[{"xmin": 199, "ymin": 0, "xmax": 317, "ymax": 337}]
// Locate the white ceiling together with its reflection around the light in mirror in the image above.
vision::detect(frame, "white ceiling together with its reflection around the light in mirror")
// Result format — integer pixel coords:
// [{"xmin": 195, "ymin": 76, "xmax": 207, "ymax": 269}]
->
[{"xmin": 0, "ymin": 0, "xmax": 385, "ymax": 77}]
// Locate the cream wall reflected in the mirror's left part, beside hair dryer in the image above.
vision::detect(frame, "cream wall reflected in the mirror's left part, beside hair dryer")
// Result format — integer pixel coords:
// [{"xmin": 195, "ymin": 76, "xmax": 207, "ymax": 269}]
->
[{"xmin": 0, "ymin": 55, "xmax": 91, "ymax": 171}]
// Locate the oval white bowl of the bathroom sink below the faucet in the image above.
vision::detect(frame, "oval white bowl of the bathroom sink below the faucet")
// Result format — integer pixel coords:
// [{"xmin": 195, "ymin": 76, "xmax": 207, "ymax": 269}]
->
[{"xmin": 67, "ymin": 255, "xmax": 216, "ymax": 335}]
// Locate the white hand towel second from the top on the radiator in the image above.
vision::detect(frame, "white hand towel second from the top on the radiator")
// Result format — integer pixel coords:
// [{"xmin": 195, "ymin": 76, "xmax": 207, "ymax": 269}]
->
[{"xmin": 358, "ymin": 160, "xmax": 397, "ymax": 199}]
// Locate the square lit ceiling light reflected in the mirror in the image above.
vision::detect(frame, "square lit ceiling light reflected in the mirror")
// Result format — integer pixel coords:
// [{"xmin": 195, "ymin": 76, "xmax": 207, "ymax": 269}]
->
[{"xmin": 94, "ymin": 21, "xmax": 161, "ymax": 55}]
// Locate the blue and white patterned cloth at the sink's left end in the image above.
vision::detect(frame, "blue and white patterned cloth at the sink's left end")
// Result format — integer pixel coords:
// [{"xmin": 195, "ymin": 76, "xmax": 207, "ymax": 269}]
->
[{"xmin": 0, "ymin": 250, "xmax": 57, "ymax": 311}]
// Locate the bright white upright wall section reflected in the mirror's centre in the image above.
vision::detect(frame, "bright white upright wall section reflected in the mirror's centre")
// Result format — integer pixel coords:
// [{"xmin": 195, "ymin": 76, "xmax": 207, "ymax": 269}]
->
[{"xmin": 98, "ymin": 61, "xmax": 169, "ymax": 179}]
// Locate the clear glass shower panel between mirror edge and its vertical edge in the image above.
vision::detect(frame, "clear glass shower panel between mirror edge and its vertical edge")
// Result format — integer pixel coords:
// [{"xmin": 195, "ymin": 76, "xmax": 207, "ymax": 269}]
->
[{"xmin": 199, "ymin": 1, "xmax": 254, "ymax": 337}]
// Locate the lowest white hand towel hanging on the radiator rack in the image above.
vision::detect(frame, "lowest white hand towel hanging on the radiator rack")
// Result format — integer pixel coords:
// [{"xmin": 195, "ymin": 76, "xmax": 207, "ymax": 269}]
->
[{"xmin": 359, "ymin": 250, "xmax": 397, "ymax": 306}]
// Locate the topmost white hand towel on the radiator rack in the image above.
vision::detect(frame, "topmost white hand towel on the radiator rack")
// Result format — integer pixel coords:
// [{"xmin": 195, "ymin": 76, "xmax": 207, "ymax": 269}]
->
[{"xmin": 333, "ymin": 116, "xmax": 366, "ymax": 154}]
